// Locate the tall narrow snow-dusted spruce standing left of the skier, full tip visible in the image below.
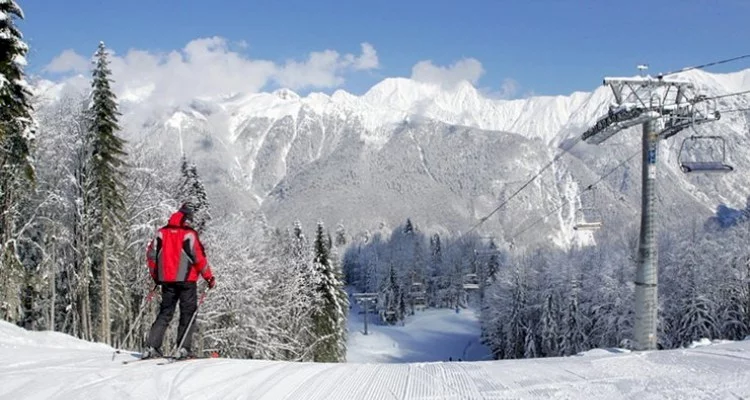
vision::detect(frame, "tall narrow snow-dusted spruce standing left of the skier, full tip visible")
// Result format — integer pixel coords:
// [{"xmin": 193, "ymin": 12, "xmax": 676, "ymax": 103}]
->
[{"xmin": 88, "ymin": 42, "xmax": 127, "ymax": 343}]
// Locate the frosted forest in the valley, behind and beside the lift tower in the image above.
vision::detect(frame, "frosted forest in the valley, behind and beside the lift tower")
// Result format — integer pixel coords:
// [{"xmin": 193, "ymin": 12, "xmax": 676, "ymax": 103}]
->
[{"xmin": 344, "ymin": 216, "xmax": 750, "ymax": 359}]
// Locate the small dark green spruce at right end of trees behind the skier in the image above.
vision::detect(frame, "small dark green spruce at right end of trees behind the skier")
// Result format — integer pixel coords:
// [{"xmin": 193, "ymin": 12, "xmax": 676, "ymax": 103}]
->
[{"xmin": 313, "ymin": 222, "xmax": 349, "ymax": 362}]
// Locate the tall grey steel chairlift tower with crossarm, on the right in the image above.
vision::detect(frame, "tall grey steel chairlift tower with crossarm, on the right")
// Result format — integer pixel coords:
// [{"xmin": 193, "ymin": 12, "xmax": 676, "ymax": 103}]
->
[{"xmin": 581, "ymin": 65, "xmax": 719, "ymax": 350}]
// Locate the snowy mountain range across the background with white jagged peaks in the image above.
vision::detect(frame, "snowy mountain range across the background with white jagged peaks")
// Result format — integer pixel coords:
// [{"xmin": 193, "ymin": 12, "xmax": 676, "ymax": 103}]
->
[{"xmin": 42, "ymin": 69, "xmax": 750, "ymax": 247}]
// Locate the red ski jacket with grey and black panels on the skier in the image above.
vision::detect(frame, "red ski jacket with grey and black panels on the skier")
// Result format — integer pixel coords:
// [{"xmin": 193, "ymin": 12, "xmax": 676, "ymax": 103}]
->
[{"xmin": 146, "ymin": 211, "xmax": 213, "ymax": 282}]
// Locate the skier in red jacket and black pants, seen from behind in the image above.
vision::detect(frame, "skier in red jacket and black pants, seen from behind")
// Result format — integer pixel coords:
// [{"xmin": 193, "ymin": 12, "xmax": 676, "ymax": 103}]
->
[{"xmin": 142, "ymin": 203, "xmax": 216, "ymax": 359}]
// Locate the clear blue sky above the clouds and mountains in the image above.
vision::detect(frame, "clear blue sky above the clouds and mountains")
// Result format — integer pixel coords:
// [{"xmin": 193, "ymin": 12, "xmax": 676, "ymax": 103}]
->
[{"xmin": 19, "ymin": 0, "xmax": 750, "ymax": 97}]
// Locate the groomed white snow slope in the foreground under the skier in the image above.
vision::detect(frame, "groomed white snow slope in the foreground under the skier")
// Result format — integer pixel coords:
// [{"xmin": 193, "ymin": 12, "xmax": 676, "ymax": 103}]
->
[{"xmin": 0, "ymin": 322, "xmax": 750, "ymax": 400}]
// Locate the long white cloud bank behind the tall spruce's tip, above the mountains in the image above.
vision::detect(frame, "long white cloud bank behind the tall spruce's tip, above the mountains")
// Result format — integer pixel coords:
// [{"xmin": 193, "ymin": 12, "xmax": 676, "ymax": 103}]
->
[{"xmin": 44, "ymin": 37, "xmax": 378, "ymax": 103}]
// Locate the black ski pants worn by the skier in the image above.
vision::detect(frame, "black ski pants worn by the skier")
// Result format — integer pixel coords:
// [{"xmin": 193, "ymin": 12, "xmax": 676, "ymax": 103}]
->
[{"xmin": 146, "ymin": 282, "xmax": 198, "ymax": 352}]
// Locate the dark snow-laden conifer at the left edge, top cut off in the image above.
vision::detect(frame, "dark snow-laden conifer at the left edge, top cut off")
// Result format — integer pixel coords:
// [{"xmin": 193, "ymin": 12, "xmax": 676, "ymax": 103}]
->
[{"xmin": 0, "ymin": 0, "xmax": 34, "ymax": 322}]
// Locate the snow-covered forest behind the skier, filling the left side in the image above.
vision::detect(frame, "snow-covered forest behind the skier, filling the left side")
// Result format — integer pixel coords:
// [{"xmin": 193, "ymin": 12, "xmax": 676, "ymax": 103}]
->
[{"xmin": 0, "ymin": 6, "xmax": 349, "ymax": 362}]
